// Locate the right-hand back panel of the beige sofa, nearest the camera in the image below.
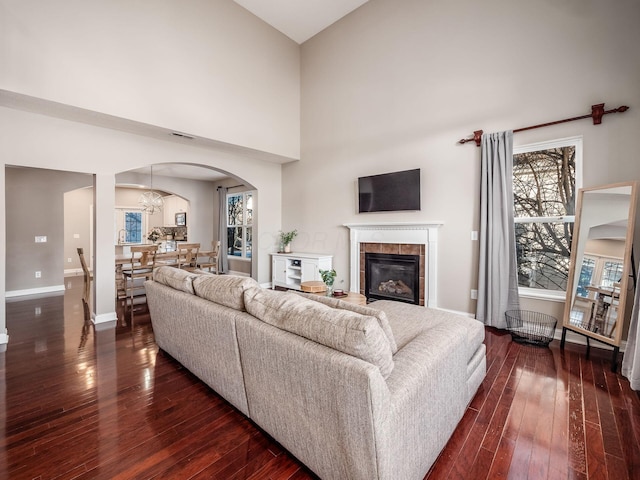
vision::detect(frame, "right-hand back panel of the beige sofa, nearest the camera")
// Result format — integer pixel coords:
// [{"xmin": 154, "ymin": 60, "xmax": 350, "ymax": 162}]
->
[{"xmin": 237, "ymin": 318, "xmax": 390, "ymax": 480}]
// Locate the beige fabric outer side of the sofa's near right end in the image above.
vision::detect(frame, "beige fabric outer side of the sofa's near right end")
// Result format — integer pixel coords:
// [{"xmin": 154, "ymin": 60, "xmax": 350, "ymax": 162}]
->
[{"xmin": 376, "ymin": 324, "xmax": 467, "ymax": 478}]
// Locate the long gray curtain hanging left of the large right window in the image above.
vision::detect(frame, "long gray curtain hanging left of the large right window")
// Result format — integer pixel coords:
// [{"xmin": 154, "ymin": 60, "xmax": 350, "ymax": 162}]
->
[{"xmin": 476, "ymin": 131, "xmax": 520, "ymax": 328}]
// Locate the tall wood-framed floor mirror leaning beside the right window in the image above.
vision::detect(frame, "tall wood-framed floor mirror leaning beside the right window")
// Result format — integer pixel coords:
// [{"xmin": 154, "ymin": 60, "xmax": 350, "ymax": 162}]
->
[{"xmin": 560, "ymin": 182, "xmax": 637, "ymax": 371}]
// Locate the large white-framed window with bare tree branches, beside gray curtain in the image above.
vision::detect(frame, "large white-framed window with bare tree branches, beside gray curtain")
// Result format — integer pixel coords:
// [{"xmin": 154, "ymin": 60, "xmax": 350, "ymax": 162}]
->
[{"xmin": 513, "ymin": 138, "xmax": 582, "ymax": 298}]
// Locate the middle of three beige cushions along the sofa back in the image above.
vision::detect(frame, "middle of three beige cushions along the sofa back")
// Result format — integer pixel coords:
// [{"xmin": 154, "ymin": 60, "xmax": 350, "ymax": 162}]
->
[{"xmin": 193, "ymin": 275, "xmax": 259, "ymax": 312}]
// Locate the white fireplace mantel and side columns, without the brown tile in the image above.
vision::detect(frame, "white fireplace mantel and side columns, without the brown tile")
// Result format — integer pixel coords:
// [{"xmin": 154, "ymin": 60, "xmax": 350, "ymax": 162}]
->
[{"xmin": 344, "ymin": 222, "xmax": 443, "ymax": 307}]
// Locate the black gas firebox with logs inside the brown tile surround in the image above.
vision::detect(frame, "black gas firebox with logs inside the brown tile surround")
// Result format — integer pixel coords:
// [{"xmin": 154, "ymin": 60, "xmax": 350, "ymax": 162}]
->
[{"xmin": 364, "ymin": 253, "xmax": 420, "ymax": 305}]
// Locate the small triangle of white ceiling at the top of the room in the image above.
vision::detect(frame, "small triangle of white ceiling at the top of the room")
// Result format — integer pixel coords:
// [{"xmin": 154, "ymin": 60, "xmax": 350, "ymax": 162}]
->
[{"xmin": 234, "ymin": 0, "xmax": 368, "ymax": 43}]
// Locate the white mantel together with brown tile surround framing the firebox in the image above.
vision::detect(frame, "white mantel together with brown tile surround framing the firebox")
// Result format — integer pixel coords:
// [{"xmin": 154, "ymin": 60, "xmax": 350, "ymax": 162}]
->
[{"xmin": 345, "ymin": 222, "xmax": 442, "ymax": 307}]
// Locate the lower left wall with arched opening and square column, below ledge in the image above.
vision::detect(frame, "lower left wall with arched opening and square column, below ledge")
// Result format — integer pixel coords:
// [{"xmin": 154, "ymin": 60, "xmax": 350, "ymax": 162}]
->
[{"xmin": 0, "ymin": 107, "xmax": 282, "ymax": 340}]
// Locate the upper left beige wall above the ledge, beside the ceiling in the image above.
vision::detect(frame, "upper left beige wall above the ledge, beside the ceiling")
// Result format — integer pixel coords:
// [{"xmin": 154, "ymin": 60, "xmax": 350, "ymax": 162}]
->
[{"xmin": 0, "ymin": 0, "xmax": 300, "ymax": 158}]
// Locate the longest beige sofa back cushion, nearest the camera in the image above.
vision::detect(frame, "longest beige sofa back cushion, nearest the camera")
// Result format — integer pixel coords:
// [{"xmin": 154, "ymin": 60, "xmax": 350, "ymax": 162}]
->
[{"xmin": 245, "ymin": 287, "xmax": 393, "ymax": 378}]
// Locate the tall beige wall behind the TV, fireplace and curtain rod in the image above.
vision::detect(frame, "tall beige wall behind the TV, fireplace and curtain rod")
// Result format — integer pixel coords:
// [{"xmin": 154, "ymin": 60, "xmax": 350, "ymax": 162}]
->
[{"xmin": 294, "ymin": 0, "xmax": 640, "ymax": 318}]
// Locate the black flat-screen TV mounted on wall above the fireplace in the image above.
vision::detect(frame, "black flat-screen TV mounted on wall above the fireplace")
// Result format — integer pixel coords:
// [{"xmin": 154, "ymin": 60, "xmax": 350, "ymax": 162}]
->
[{"xmin": 358, "ymin": 168, "xmax": 420, "ymax": 213}]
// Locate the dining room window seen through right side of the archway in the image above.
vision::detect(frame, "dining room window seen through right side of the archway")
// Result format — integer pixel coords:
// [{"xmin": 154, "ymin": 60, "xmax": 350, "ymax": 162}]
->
[{"xmin": 227, "ymin": 192, "xmax": 254, "ymax": 258}]
